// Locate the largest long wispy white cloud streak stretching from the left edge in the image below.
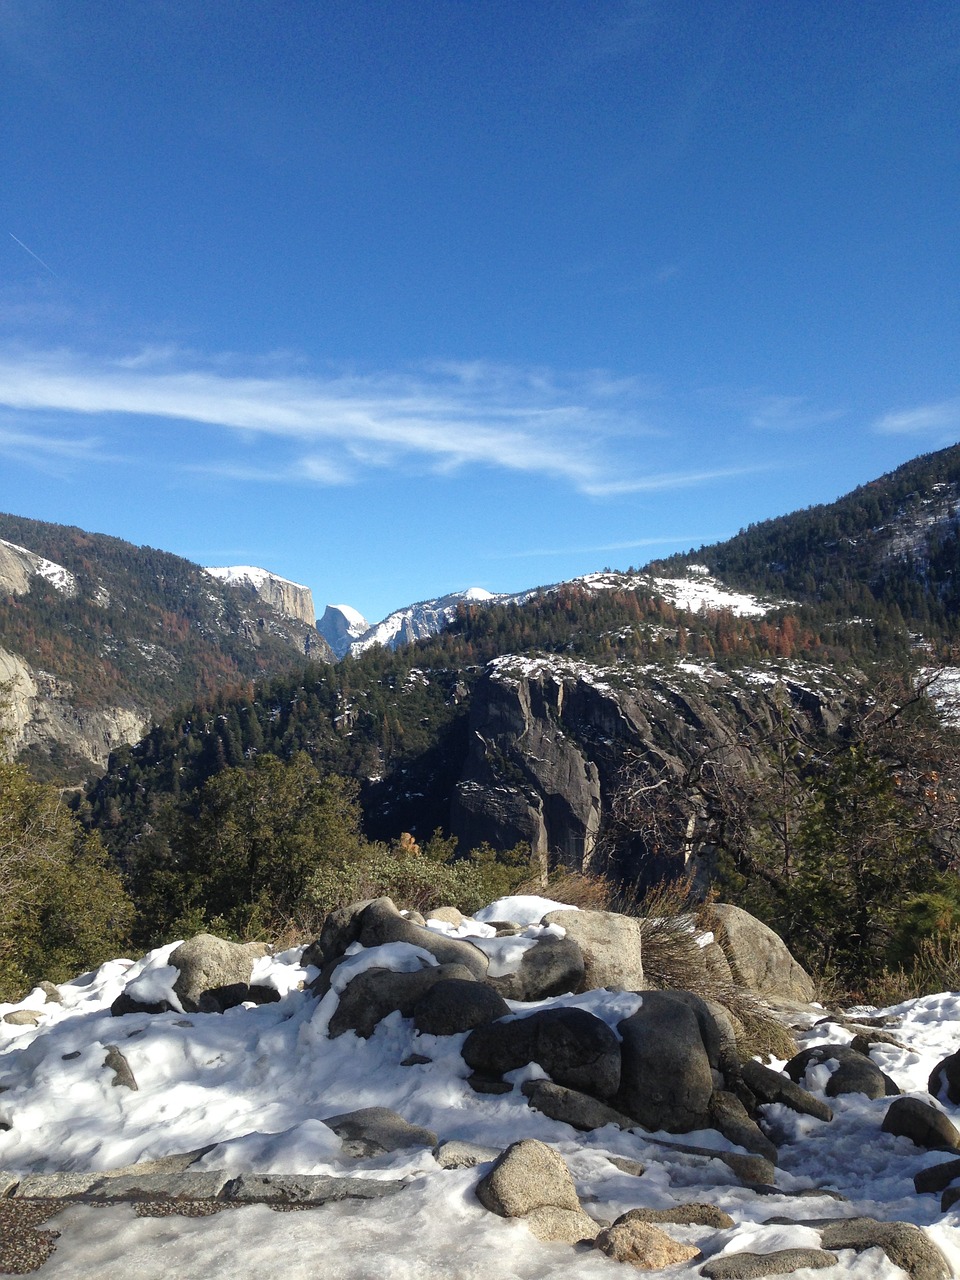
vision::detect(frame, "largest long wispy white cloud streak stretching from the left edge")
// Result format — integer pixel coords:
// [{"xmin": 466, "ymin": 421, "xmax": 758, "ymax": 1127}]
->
[{"xmin": 0, "ymin": 347, "xmax": 744, "ymax": 497}]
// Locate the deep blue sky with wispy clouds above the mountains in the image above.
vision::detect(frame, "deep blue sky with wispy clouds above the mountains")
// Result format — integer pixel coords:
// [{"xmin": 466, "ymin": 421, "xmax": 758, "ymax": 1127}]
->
[{"xmin": 0, "ymin": 0, "xmax": 960, "ymax": 620}]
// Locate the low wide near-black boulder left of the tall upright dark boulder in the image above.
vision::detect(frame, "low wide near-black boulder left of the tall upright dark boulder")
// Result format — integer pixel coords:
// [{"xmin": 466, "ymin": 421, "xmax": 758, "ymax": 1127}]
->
[{"xmin": 461, "ymin": 1007, "xmax": 620, "ymax": 1098}]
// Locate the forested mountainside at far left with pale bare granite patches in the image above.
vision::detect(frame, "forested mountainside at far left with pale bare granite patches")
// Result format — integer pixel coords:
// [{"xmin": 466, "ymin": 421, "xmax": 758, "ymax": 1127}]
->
[{"xmin": 0, "ymin": 516, "xmax": 332, "ymax": 781}]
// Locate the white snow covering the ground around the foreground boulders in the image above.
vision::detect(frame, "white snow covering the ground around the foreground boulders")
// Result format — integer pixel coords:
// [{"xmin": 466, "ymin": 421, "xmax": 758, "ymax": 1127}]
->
[{"xmin": 0, "ymin": 901, "xmax": 960, "ymax": 1280}]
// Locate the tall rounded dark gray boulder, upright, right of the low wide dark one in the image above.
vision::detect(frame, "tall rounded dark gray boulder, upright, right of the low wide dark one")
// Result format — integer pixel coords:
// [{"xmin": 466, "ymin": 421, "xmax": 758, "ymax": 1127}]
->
[{"xmin": 614, "ymin": 991, "xmax": 714, "ymax": 1133}]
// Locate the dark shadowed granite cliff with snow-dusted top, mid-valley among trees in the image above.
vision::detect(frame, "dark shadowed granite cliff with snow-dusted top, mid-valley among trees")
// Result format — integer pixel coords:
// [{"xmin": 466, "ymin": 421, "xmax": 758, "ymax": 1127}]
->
[{"xmin": 452, "ymin": 657, "xmax": 842, "ymax": 872}]
